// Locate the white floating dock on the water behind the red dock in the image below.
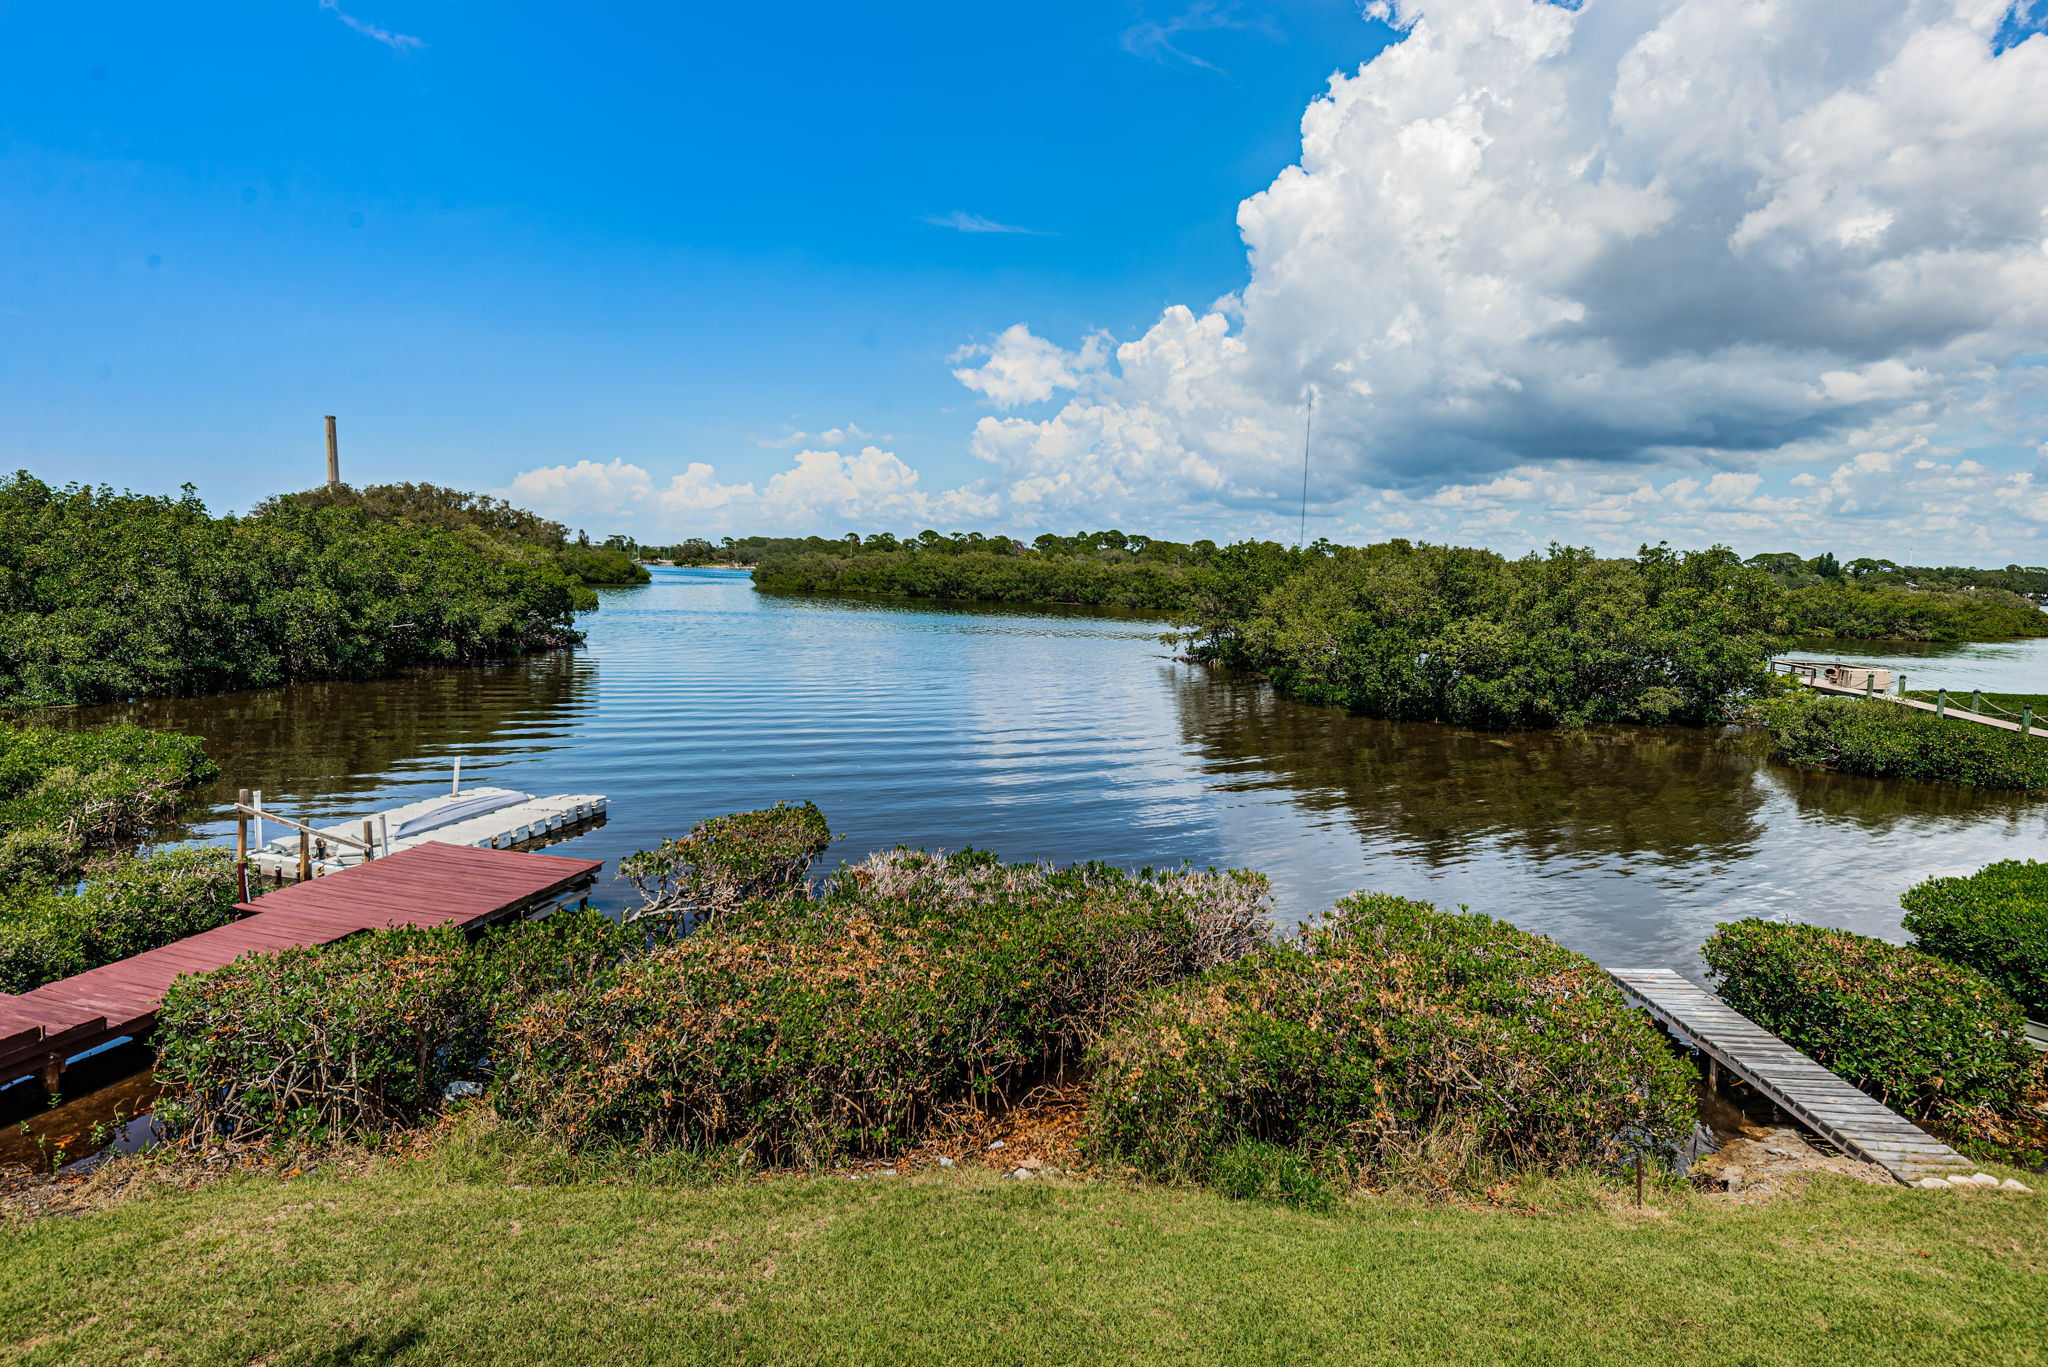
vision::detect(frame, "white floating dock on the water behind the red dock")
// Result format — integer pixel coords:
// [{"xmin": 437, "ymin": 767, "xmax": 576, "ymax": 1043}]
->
[{"xmin": 250, "ymin": 787, "xmax": 604, "ymax": 879}]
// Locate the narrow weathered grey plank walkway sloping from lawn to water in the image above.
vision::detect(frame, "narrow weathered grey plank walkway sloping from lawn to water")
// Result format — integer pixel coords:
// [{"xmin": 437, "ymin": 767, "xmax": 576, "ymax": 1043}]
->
[{"xmin": 1608, "ymin": 967, "xmax": 1976, "ymax": 1187}]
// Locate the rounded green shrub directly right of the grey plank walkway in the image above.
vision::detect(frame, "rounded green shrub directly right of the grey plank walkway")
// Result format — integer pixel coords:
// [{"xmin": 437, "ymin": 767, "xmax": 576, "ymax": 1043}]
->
[{"xmin": 1700, "ymin": 920, "xmax": 2042, "ymax": 1144}]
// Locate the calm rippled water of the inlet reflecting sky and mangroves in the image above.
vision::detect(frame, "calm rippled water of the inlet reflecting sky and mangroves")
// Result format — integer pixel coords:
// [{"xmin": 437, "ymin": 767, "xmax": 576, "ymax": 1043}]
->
[{"xmin": 44, "ymin": 570, "xmax": 2048, "ymax": 971}]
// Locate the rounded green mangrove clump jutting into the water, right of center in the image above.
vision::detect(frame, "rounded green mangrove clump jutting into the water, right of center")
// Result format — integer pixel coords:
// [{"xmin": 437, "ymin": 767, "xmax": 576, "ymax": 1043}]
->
[{"xmin": 1178, "ymin": 541, "xmax": 1782, "ymax": 728}]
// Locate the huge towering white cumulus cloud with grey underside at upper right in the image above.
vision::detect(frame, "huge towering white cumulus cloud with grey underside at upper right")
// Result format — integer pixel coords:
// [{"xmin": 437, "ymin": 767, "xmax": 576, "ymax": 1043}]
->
[{"xmin": 956, "ymin": 0, "xmax": 2048, "ymax": 545}]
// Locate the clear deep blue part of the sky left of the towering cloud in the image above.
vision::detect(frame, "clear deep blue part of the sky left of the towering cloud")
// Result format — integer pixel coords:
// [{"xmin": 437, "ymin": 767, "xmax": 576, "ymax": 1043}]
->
[{"xmin": 0, "ymin": 0, "xmax": 1391, "ymax": 518}]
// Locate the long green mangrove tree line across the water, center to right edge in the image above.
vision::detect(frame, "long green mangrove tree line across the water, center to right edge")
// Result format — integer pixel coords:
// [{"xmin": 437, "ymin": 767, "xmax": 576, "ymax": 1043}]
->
[{"xmin": 731, "ymin": 531, "xmax": 2048, "ymax": 726}]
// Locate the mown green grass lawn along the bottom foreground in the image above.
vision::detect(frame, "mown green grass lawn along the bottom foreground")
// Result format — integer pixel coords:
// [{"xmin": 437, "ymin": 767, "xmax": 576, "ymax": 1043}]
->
[{"xmin": 0, "ymin": 1160, "xmax": 2048, "ymax": 1367}]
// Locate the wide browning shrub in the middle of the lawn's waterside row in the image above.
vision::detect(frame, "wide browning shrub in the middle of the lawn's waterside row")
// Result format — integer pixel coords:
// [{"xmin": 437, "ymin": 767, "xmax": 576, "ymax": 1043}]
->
[{"xmin": 496, "ymin": 851, "xmax": 1270, "ymax": 1164}]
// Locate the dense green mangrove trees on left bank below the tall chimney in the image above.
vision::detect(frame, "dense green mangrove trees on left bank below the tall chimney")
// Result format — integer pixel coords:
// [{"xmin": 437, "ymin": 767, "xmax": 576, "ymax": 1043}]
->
[{"xmin": 0, "ymin": 471, "xmax": 596, "ymax": 707}]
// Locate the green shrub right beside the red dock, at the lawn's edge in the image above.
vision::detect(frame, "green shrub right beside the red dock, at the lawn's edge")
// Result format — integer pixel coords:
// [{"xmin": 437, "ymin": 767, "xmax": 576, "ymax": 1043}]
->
[{"xmin": 156, "ymin": 908, "xmax": 637, "ymax": 1137}]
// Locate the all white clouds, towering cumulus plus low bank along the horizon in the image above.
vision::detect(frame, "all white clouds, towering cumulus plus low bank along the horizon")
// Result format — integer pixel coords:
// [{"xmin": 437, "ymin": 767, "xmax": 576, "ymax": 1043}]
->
[{"xmin": 491, "ymin": 0, "xmax": 2048, "ymax": 564}]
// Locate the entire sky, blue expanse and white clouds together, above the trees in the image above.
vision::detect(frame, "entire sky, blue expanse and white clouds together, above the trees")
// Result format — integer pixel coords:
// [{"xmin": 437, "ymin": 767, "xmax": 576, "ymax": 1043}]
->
[{"xmin": 0, "ymin": 0, "xmax": 2048, "ymax": 564}]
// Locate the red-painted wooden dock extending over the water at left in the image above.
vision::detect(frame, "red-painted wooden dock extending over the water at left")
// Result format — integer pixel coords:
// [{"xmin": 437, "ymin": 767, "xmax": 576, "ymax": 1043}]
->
[{"xmin": 0, "ymin": 842, "xmax": 602, "ymax": 1086}]
